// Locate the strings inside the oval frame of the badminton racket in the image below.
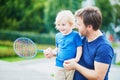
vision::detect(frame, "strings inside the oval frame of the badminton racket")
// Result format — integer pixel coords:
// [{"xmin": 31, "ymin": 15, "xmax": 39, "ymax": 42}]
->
[{"xmin": 15, "ymin": 39, "xmax": 36, "ymax": 58}]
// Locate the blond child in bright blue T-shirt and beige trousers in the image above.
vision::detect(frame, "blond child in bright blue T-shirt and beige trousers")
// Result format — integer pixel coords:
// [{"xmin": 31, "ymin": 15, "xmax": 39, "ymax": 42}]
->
[{"xmin": 44, "ymin": 10, "xmax": 82, "ymax": 80}]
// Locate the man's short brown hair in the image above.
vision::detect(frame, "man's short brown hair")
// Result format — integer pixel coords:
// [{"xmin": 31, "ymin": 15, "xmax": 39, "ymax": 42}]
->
[{"xmin": 75, "ymin": 6, "xmax": 102, "ymax": 30}]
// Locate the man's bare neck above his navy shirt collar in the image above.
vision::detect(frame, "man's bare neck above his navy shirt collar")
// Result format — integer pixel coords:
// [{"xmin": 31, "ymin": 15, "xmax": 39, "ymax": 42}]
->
[{"xmin": 87, "ymin": 30, "xmax": 102, "ymax": 42}]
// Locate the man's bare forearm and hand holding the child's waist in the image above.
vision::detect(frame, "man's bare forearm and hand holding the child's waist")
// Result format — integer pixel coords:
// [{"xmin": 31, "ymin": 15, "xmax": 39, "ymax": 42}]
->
[{"xmin": 64, "ymin": 60, "xmax": 109, "ymax": 80}]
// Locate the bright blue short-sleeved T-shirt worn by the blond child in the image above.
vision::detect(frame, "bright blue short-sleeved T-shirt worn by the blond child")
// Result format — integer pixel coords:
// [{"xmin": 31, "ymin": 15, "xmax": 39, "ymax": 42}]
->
[{"xmin": 56, "ymin": 31, "xmax": 82, "ymax": 67}]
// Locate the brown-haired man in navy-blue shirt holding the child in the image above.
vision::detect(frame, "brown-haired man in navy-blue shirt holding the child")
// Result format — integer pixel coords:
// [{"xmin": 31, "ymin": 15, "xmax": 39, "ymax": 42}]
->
[{"xmin": 64, "ymin": 7, "xmax": 114, "ymax": 80}]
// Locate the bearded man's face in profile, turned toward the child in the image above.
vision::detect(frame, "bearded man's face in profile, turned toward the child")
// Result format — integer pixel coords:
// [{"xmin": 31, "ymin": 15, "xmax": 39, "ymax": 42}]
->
[{"xmin": 76, "ymin": 17, "xmax": 87, "ymax": 36}]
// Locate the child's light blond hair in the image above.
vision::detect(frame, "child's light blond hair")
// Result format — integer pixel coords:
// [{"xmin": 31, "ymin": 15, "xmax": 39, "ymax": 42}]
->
[{"xmin": 55, "ymin": 10, "xmax": 75, "ymax": 26}]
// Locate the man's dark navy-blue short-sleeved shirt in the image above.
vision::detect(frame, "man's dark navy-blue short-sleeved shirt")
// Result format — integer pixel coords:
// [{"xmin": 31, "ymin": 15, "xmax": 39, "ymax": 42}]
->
[{"xmin": 73, "ymin": 35, "xmax": 114, "ymax": 80}]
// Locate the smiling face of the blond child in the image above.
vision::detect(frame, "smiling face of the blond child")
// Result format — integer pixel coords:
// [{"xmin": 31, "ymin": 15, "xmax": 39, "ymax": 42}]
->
[{"xmin": 56, "ymin": 20, "xmax": 72, "ymax": 35}]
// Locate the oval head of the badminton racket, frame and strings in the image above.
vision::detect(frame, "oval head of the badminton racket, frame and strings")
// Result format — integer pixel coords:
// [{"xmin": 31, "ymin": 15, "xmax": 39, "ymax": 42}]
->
[{"xmin": 13, "ymin": 37, "xmax": 37, "ymax": 59}]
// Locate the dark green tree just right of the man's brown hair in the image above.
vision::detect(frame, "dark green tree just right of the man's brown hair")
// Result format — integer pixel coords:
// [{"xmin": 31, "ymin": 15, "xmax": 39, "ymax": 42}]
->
[{"xmin": 95, "ymin": 0, "xmax": 113, "ymax": 32}]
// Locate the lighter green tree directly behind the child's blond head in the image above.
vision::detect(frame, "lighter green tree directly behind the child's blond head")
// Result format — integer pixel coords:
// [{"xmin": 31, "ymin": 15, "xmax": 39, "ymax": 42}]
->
[{"xmin": 44, "ymin": 0, "xmax": 82, "ymax": 31}]
